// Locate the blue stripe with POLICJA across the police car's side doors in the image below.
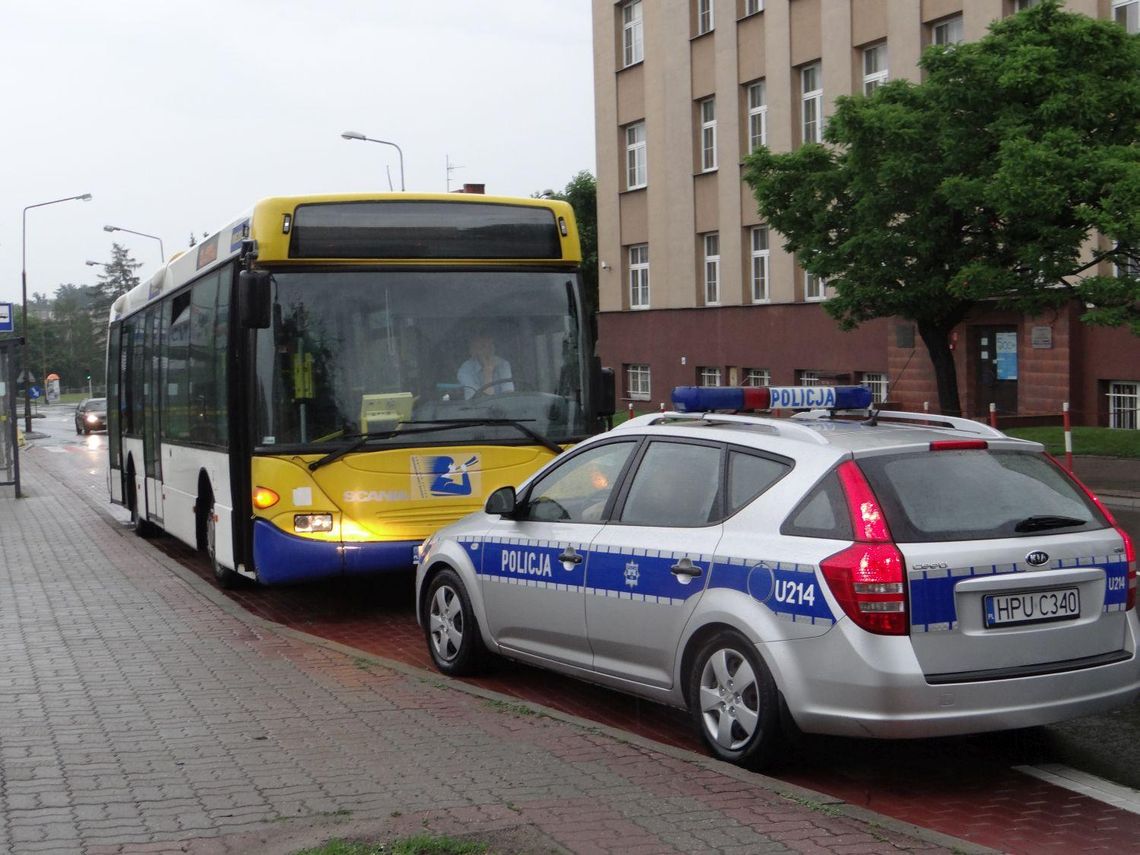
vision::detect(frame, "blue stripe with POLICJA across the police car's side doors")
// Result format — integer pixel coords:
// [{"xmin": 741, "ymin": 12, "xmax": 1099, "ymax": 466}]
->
[{"xmin": 459, "ymin": 537, "xmax": 713, "ymax": 605}]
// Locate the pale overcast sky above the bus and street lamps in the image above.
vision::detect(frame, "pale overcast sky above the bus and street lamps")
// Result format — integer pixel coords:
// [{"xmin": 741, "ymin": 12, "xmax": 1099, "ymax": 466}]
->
[{"xmin": 0, "ymin": 0, "xmax": 596, "ymax": 312}]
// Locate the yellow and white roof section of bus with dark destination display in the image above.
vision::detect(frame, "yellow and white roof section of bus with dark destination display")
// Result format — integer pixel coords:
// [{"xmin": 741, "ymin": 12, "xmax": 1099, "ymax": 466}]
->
[{"xmin": 111, "ymin": 193, "xmax": 581, "ymax": 321}]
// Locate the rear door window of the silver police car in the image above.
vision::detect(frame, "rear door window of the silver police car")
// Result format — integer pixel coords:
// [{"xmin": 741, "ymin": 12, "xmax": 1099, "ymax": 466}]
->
[{"xmin": 621, "ymin": 440, "xmax": 720, "ymax": 526}]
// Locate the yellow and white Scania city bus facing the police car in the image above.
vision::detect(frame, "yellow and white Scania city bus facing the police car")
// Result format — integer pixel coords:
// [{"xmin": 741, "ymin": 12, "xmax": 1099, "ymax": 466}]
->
[{"xmin": 107, "ymin": 193, "xmax": 613, "ymax": 586}]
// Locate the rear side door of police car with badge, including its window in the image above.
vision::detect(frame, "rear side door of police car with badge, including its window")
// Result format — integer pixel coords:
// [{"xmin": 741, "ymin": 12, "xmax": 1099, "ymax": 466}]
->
[{"xmin": 586, "ymin": 440, "xmax": 723, "ymax": 687}]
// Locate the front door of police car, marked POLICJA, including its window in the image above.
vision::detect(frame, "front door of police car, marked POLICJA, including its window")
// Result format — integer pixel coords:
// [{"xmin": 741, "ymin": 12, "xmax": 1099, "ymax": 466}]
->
[{"xmin": 480, "ymin": 440, "xmax": 637, "ymax": 668}]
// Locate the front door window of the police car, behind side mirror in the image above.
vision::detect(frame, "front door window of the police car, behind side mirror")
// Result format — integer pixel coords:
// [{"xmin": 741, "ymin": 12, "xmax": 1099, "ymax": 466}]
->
[{"xmin": 522, "ymin": 441, "xmax": 637, "ymax": 522}]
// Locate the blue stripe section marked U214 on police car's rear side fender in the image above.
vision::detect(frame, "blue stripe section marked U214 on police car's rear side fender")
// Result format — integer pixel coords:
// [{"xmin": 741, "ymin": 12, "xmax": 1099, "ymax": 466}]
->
[{"xmin": 709, "ymin": 557, "xmax": 836, "ymax": 626}]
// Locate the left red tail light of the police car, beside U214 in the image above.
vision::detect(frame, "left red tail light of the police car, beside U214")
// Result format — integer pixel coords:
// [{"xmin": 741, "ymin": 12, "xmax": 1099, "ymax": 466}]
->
[{"xmin": 820, "ymin": 461, "xmax": 910, "ymax": 635}]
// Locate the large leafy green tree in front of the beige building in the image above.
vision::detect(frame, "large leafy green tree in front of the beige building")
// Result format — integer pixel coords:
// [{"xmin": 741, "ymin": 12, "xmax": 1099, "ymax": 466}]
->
[{"xmin": 744, "ymin": 0, "xmax": 1140, "ymax": 415}]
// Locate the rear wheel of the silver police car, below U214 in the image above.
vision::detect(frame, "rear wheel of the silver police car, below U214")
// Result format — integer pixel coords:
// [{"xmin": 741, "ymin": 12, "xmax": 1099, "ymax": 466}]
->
[{"xmin": 689, "ymin": 632, "xmax": 780, "ymax": 767}]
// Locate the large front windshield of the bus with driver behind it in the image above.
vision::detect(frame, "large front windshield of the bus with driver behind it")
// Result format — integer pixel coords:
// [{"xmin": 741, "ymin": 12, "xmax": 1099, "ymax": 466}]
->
[{"xmin": 254, "ymin": 269, "xmax": 592, "ymax": 450}]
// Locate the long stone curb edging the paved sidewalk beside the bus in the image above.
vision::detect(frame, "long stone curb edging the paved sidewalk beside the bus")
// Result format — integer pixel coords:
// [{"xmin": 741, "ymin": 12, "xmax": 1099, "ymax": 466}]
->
[{"xmin": 62, "ymin": 469, "xmax": 1000, "ymax": 855}]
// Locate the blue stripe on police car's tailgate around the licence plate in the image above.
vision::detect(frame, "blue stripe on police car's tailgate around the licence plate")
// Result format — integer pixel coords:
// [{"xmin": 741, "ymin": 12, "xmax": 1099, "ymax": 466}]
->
[{"xmin": 907, "ymin": 555, "xmax": 1129, "ymax": 633}]
